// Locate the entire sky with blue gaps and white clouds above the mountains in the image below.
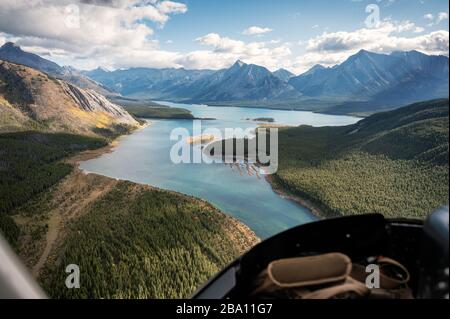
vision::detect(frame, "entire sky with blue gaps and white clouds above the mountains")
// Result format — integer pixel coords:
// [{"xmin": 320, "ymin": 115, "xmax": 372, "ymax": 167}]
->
[{"xmin": 0, "ymin": 0, "xmax": 449, "ymax": 73}]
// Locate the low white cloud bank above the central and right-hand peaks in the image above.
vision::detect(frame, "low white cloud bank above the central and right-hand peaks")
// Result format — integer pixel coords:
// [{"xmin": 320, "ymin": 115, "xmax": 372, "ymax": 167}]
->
[{"xmin": 190, "ymin": 20, "xmax": 449, "ymax": 73}]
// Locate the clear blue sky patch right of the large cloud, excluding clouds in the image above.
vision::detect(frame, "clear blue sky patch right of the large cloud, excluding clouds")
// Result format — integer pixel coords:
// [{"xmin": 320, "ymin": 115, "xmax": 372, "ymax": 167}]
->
[{"xmin": 157, "ymin": 0, "xmax": 448, "ymax": 51}]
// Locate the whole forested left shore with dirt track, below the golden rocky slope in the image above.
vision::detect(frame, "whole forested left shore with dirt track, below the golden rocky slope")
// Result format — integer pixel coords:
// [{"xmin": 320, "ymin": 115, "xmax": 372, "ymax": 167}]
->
[{"xmin": 0, "ymin": 132, "xmax": 258, "ymax": 298}]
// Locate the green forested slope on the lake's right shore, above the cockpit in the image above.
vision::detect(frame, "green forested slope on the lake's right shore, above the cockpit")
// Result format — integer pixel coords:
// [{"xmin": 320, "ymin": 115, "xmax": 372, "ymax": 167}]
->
[{"xmin": 274, "ymin": 100, "xmax": 449, "ymax": 218}]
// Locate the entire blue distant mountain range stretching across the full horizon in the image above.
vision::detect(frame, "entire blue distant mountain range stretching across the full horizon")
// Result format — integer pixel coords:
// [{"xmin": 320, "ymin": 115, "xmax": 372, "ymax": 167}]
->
[{"xmin": 0, "ymin": 43, "xmax": 449, "ymax": 114}]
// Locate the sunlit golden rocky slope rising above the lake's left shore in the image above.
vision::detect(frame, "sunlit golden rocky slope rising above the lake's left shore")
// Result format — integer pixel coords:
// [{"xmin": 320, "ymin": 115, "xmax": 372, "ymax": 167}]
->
[{"xmin": 0, "ymin": 60, "xmax": 139, "ymax": 135}]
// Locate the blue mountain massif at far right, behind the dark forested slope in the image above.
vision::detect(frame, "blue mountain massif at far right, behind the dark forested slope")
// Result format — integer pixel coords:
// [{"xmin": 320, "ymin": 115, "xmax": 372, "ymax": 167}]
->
[{"xmin": 289, "ymin": 50, "xmax": 449, "ymax": 104}]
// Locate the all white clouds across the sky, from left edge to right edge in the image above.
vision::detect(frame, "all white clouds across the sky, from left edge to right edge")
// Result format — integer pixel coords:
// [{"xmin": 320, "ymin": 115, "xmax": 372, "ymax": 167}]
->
[{"xmin": 0, "ymin": 0, "xmax": 449, "ymax": 73}]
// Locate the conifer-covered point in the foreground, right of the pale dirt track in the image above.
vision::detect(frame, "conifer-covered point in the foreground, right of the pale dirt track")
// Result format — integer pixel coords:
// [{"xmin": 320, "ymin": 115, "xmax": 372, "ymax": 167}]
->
[{"xmin": 37, "ymin": 182, "xmax": 256, "ymax": 298}]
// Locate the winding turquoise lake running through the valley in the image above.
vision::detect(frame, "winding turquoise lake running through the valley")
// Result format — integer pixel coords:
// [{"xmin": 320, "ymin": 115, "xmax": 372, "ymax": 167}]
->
[{"xmin": 80, "ymin": 102, "xmax": 360, "ymax": 238}]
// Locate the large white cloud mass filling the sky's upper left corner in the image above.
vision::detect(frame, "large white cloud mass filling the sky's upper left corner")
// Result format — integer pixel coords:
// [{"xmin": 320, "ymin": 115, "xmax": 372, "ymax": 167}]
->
[{"xmin": 0, "ymin": 0, "xmax": 187, "ymax": 67}]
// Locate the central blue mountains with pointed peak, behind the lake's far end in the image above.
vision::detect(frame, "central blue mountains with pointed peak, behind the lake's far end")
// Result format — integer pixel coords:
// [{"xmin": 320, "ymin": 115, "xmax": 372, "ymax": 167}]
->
[{"xmin": 84, "ymin": 61, "xmax": 301, "ymax": 103}]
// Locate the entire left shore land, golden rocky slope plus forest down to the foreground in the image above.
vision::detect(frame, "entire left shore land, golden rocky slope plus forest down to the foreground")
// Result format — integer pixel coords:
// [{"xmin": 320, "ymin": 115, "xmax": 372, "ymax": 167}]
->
[{"xmin": 0, "ymin": 61, "xmax": 258, "ymax": 298}]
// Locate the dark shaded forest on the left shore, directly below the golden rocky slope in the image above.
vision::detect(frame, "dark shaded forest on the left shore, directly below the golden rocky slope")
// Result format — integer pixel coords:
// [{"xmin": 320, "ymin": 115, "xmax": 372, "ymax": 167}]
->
[{"xmin": 0, "ymin": 132, "xmax": 106, "ymax": 244}]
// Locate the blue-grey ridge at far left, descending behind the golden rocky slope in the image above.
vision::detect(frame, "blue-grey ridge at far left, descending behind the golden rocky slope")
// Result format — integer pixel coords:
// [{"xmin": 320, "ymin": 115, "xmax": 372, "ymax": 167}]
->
[{"xmin": 0, "ymin": 42, "xmax": 117, "ymax": 95}]
